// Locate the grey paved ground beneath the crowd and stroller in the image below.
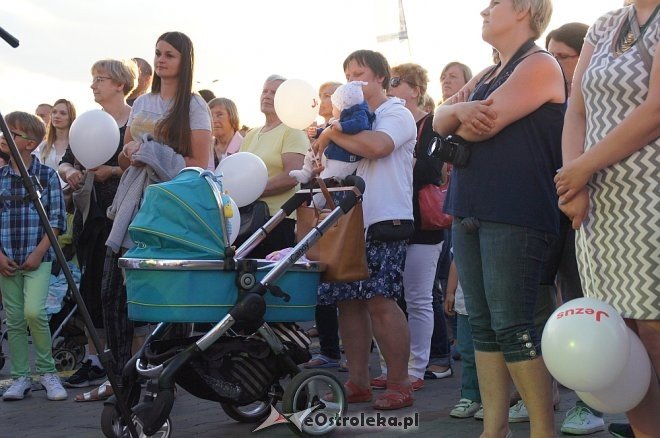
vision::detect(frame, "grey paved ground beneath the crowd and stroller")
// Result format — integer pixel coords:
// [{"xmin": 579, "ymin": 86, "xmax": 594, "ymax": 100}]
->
[{"xmin": 0, "ymin": 316, "xmax": 624, "ymax": 438}]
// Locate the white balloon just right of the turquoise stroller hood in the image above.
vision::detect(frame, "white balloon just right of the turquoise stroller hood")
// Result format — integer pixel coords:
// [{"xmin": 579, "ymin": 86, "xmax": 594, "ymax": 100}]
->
[{"xmin": 215, "ymin": 152, "xmax": 268, "ymax": 207}]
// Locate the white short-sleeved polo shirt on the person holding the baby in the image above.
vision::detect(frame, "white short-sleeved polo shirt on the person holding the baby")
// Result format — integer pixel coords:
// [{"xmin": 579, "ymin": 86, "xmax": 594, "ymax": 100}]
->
[{"xmin": 357, "ymin": 97, "xmax": 417, "ymax": 228}]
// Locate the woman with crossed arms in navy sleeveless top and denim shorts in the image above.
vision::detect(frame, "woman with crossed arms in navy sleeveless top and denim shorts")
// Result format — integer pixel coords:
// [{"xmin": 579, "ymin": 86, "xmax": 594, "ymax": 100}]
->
[{"xmin": 433, "ymin": 0, "xmax": 567, "ymax": 437}]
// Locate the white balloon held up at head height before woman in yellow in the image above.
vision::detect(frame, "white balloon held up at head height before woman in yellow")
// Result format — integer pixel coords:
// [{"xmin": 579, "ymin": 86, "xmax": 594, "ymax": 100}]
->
[{"xmin": 274, "ymin": 79, "xmax": 319, "ymax": 129}]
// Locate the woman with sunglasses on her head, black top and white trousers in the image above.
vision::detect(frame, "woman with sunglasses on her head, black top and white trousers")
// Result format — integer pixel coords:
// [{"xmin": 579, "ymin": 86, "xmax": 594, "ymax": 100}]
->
[{"xmin": 371, "ymin": 63, "xmax": 449, "ymax": 390}]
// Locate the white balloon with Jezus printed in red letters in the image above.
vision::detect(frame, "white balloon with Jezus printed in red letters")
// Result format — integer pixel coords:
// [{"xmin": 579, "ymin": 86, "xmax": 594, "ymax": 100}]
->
[{"xmin": 541, "ymin": 297, "xmax": 630, "ymax": 391}]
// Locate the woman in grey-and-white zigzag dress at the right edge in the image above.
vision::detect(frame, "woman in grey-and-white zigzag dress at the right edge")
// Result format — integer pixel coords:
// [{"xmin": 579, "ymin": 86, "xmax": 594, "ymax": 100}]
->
[{"xmin": 555, "ymin": 0, "xmax": 660, "ymax": 437}]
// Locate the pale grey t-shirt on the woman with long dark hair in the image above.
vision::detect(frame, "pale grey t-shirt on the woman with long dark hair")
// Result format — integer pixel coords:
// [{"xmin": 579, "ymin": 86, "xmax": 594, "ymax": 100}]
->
[{"xmin": 128, "ymin": 93, "xmax": 215, "ymax": 170}]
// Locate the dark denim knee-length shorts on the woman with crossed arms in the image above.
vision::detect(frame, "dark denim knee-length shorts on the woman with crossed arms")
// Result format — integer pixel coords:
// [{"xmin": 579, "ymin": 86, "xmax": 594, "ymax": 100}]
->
[{"xmin": 452, "ymin": 218, "xmax": 552, "ymax": 362}]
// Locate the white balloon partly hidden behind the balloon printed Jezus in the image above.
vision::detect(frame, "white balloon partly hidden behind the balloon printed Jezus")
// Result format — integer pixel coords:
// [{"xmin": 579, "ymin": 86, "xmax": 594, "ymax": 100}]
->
[{"xmin": 577, "ymin": 329, "xmax": 651, "ymax": 414}]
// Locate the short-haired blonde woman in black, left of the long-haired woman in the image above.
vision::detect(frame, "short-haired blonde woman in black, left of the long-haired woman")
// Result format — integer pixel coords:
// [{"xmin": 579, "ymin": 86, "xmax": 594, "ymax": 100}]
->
[{"xmin": 59, "ymin": 59, "xmax": 138, "ymax": 396}]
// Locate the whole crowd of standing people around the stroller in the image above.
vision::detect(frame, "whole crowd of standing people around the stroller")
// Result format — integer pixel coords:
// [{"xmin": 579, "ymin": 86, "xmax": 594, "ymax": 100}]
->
[{"xmin": 0, "ymin": 0, "xmax": 660, "ymax": 437}]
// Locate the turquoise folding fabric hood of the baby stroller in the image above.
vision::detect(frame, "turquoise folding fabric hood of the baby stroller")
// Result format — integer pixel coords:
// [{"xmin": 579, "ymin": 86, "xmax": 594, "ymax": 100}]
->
[{"xmin": 125, "ymin": 168, "xmax": 229, "ymax": 260}]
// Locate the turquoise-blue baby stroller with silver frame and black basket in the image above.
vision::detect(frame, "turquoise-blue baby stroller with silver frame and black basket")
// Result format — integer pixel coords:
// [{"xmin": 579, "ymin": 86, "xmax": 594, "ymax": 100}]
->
[{"xmin": 101, "ymin": 168, "xmax": 364, "ymax": 437}]
